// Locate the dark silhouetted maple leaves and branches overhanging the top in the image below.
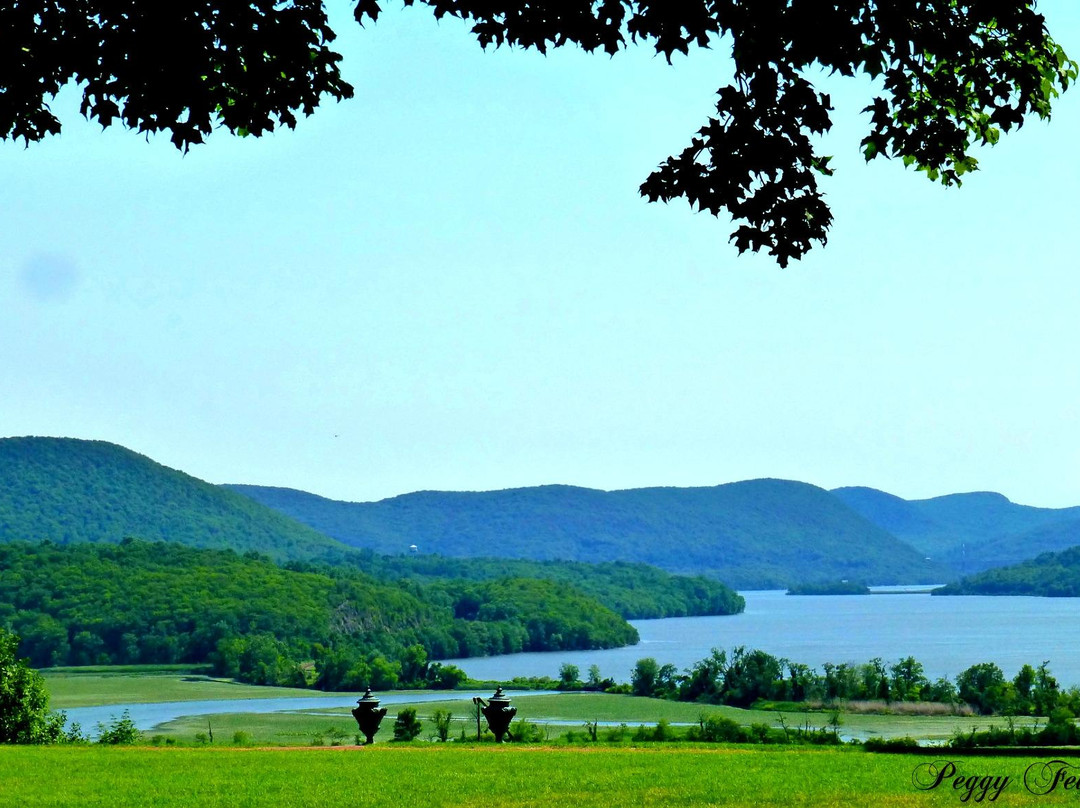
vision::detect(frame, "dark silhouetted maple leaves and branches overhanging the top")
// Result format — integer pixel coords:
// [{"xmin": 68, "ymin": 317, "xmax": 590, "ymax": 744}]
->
[{"xmin": 0, "ymin": 0, "xmax": 1078, "ymax": 266}]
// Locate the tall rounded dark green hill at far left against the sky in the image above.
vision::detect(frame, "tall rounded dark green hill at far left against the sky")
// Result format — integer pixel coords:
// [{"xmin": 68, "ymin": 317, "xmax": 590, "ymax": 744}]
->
[{"xmin": 0, "ymin": 437, "xmax": 348, "ymax": 558}]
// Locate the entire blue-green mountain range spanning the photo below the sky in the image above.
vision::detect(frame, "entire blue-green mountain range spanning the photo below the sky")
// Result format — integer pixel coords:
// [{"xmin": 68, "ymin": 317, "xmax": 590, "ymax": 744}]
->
[{"xmin": 0, "ymin": 437, "xmax": 1080, "ymax": 589}]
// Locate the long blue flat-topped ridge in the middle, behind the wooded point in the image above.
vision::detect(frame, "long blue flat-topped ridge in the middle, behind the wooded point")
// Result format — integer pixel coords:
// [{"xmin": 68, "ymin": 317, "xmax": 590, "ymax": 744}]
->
[{"xmin": 229, "ymin": 480, "xmax": 948, "ymax": 588}]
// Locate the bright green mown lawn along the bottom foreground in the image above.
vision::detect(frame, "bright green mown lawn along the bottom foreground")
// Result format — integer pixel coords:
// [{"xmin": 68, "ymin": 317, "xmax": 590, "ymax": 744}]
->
[{"xmin": 0, "ymin": 744, "xmax": 1077, "ymax": 808}]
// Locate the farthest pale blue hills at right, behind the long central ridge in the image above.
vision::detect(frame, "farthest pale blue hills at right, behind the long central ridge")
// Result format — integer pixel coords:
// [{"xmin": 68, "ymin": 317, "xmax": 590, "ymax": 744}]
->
[{"xmin": 833, "ymin": 487, "xmax": 1080, "ymax": 574}]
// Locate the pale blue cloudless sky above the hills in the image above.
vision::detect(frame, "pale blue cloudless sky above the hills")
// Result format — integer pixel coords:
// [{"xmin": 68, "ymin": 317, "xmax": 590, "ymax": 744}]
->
[{"xmin": 0, "ymin": 0, "xmax": 1080, "ymax": 507}]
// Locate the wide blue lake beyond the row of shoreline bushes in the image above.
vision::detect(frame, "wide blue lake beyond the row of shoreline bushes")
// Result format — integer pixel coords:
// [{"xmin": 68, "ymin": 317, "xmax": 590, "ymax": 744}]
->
[{"xmin": 438, "ymin": 591, "xmax": 1080, "ymax": 686}]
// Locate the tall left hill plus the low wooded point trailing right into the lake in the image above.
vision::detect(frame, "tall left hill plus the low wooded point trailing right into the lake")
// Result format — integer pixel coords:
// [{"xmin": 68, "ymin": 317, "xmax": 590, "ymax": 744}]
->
[{"xmin": 0, "ymin": 439, "xmax": 743, "ymax": 618}]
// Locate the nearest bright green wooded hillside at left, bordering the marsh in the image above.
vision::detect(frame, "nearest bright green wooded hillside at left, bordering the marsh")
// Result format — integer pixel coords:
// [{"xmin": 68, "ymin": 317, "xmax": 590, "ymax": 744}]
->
[{"xmin": 0, "ymin": 540, "xmax": 637, "ymax": 689}]
